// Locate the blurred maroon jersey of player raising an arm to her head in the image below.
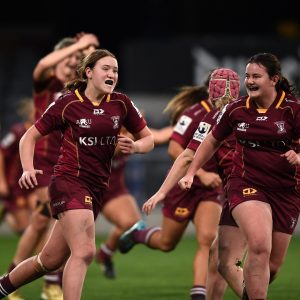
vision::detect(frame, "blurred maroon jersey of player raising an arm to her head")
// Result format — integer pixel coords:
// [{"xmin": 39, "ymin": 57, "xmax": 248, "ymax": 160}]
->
[{"xmin": 33, "ymin": 76, "xmax": 64, "ymax": 163}]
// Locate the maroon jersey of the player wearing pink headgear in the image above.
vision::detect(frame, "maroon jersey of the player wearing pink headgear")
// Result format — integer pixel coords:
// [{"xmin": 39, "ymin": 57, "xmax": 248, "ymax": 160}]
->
[{"xmin": 187, "ymin": 109, "xmax": 236, "ymax": 186}]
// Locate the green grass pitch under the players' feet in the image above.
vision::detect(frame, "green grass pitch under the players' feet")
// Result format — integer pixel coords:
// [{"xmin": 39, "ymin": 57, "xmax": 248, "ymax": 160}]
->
[{"xmin": 0, "ymin": 236, "xmax": 300, "ymax": 300}]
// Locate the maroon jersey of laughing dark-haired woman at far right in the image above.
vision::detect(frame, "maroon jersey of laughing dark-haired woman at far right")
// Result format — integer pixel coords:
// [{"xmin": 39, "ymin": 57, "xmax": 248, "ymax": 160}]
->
[{"xmin": 212, "ymin": 91, "xmax": 300, "ymax": 190}]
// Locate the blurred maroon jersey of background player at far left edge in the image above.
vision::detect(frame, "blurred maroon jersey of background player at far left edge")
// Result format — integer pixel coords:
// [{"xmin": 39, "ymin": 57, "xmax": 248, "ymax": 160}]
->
[{"xmin": 0, "ymin": 123, "xmax": 29, "ymax": 188}]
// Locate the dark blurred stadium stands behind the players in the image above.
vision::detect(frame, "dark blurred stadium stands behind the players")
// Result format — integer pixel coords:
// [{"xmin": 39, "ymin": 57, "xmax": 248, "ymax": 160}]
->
[{"xmin": 0, "ymin": 0, "xmax": 300, "ymax": 201}]
